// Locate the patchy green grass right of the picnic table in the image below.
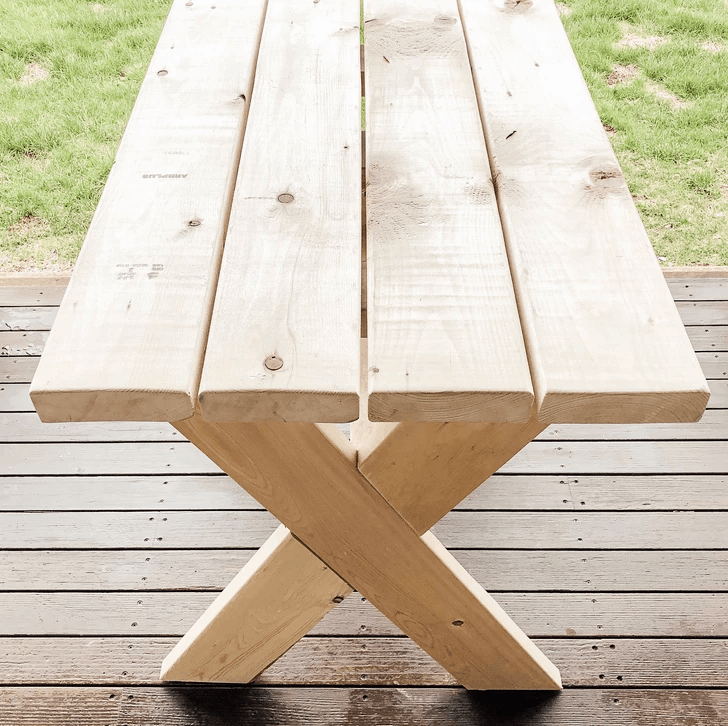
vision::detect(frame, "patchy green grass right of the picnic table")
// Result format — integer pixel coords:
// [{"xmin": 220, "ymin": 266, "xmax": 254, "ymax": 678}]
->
[{"xmin": 562, "ymin": 0, "xmax": 728, "ymax": 265}]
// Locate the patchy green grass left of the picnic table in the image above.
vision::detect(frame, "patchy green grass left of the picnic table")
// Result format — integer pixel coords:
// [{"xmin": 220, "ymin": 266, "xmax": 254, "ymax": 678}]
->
[{"xmin": 0, "ymin": 0, "xmax": 171, "ymax": 272}]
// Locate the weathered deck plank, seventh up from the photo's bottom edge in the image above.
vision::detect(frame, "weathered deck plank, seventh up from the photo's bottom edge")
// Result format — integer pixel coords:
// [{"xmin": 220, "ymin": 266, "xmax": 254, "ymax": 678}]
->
[{"xmin": 5, "ymin": 441, "xmax": 728, "ymax": 478}]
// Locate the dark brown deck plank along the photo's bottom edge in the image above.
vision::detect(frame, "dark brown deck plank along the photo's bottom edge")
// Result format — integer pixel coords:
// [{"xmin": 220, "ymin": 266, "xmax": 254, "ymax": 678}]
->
[{"xmin": 0, "ymin": 686, "xmax": 728, "ymax": 726}]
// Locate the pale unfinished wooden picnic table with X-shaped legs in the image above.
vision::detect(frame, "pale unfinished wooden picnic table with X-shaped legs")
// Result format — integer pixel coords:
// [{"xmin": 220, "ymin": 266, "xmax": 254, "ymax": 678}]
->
[{"xmin": 31, "ymin": 0, "xmax": 709, "ymax": 689}]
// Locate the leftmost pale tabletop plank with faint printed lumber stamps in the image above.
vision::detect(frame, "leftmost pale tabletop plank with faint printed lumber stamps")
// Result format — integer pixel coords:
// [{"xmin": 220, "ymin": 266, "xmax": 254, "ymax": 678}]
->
[{"xmin": 32, "ymin": 0, "xmax": 266, "ymax": 421}]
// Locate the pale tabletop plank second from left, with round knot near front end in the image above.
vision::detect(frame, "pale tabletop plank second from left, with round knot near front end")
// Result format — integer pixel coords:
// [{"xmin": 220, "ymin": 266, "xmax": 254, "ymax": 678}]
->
[{"xmin": 198, "ymin": 0, "xmax": 362, "ymax": 422}]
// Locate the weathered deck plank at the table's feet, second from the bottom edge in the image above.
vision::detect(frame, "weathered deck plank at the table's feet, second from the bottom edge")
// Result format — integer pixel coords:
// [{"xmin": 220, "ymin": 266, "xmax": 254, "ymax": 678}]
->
[{"xmin": 0, "ymin": 637, "xmax": 725, "ymax": 688}]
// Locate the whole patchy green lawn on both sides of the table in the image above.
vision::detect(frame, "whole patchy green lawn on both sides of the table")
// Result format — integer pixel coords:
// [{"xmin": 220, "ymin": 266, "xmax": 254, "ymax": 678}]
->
[{"xmin": 0, "ymin": 0, "xmax": 728, "ymax": 272}]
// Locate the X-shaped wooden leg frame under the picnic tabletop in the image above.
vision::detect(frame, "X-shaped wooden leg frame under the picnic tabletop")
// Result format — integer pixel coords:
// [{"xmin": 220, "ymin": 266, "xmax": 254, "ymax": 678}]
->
[{"xmin": 162, "ymin": 416, "xmax": 560, "ymax": 689}]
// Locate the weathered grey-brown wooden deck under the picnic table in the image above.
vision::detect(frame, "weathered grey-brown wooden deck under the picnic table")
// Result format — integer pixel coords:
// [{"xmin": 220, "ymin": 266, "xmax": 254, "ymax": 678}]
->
[{"xmin": 0, "ymin": 277, "xmax": 728, "ymax": 726}]
